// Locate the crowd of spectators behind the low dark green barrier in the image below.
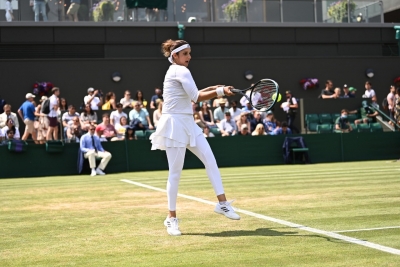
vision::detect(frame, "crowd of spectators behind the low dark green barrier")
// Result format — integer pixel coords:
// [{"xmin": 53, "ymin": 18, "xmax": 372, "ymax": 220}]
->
[{"xmin": 0, "ymin": 80, "xmax": 400, "ymax": 144}]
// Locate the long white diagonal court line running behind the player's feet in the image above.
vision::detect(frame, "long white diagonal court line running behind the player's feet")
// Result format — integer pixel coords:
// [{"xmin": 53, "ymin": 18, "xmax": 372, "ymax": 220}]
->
[{"xmin": 121, "ymin": 179, "xmax": 400, "ymax": 255}]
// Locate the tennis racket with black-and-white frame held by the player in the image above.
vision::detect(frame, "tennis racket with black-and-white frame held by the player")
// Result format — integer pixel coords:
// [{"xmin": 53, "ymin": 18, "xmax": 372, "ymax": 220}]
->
[{"xmin": 231, "ymin": 79, "xmax": 279, "ymax": 112}]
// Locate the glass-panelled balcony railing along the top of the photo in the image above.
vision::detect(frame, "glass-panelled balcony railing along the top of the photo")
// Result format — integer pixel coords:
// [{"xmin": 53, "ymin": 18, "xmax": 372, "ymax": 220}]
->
[{"xmin": 0, "ymin": 0, "xmax": 384, "ymax": 23}]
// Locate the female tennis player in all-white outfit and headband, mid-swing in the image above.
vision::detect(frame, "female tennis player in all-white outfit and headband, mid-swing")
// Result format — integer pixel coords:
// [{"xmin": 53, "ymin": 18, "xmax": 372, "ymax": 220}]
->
[{"xmin": 150, "ymin": 40, "xmax": 240, "ymax": 236}]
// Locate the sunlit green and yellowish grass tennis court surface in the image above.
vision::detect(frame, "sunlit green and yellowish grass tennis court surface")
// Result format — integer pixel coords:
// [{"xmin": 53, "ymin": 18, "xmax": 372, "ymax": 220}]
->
[{"xmin": 0, "ymin": 161, "xmax": 400, "ymax": 267}]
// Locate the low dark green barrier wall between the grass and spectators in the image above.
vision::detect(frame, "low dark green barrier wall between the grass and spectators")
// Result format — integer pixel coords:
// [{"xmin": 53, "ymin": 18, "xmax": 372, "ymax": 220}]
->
[{"xmin": 0, "ymin": 132, "xmax": 400, "ymax": 178}]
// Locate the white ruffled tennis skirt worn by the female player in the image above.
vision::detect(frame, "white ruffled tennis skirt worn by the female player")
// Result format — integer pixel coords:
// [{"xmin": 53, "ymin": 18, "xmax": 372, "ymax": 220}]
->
[{"xmin": 150, "ymin": 114, "xmax": 203, "ymax": 150}]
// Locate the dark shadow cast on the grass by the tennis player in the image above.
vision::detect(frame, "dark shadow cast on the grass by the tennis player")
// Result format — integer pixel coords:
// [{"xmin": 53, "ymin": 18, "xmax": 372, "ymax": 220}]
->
[{"xmin": 182, "ymin": 228, "xmax": 342, "ymax": 243}]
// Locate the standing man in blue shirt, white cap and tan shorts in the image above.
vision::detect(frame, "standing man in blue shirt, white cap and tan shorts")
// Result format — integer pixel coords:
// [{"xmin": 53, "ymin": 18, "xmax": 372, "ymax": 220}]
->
[{"xmin": 18, "ymin": 93, "xmax": 36, "ymax": 142}]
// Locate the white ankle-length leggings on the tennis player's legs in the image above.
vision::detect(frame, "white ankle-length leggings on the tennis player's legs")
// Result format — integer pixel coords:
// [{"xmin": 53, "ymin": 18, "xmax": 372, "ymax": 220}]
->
[{"xmin": 166, "ymin": 135, "xmax": 224, "ymax": 211}]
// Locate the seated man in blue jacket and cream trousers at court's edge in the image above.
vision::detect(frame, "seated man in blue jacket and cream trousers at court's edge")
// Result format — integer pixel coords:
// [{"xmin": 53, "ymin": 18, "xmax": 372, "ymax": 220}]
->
[{"xmin": 80, "ymin": 125, "xmax": 111, "ymax": 176}]
